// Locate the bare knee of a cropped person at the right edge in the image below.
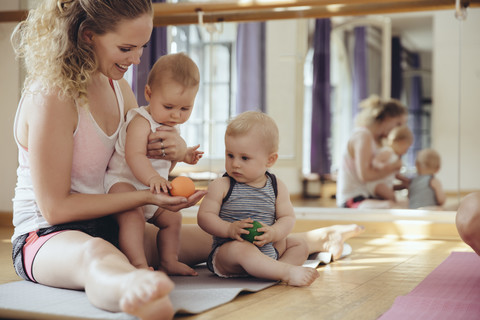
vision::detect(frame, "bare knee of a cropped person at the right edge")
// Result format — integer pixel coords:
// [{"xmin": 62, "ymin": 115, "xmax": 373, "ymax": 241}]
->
[{"xmin": 455, "ymin": 192, "xmax": 480, "ymax": 255}]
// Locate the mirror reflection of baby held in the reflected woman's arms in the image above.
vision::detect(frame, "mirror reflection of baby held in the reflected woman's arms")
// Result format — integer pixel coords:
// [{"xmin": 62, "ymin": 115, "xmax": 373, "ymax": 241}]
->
[{"xmin": 367, "ymin": 126, "xmax": 413, "ymax": 202}]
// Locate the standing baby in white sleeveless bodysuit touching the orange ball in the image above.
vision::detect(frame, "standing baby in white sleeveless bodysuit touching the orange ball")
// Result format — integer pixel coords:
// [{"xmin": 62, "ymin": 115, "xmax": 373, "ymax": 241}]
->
[{"xmin": 105, "ymin": 53, "xmax": 203, "ymax": 275}]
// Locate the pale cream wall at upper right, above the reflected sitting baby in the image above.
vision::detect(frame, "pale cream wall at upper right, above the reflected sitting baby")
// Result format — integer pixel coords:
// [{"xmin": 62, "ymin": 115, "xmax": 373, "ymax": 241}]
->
[{"xmin": 432, "ymin": 8, "xmax": 480, "ymax": 191}]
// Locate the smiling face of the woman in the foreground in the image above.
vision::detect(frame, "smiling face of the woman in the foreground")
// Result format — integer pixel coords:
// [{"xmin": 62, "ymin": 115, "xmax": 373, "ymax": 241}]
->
[{"xmin": 85, "ymin": 14, "xmax": 153, "ymax": 80}]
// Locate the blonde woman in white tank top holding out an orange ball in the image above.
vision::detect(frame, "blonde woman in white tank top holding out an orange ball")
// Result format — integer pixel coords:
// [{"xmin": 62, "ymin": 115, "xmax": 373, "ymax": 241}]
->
[{"xmin": 12, "ymin": 0, "xmax": 361, "ymax": 319}]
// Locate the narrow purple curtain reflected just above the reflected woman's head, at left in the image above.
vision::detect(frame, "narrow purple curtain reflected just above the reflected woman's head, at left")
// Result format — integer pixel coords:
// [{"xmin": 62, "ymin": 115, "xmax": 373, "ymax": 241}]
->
[{"xmin": 352, "ymin": 27, "xmax": 368, "ymax": 117}]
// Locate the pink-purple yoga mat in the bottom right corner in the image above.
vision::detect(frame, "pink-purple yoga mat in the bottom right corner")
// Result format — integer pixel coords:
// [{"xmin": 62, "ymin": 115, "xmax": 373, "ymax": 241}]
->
[{"xmin": 379, "ymin": 252, "xmax": 480, "ymax": 320}]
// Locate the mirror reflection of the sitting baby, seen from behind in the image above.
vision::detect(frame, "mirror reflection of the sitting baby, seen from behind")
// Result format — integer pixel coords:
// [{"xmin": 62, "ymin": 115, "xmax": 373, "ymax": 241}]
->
[{"xmin": 408, "ymin": 149, "xmax": 446, "ymax": 209}]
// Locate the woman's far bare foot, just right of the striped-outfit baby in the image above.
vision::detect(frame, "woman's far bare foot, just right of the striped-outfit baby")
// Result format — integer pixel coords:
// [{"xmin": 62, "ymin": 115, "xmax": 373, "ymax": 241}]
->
[{"xmin": 292, "ymin": 224, "xmax": 365, "ymax": 260}]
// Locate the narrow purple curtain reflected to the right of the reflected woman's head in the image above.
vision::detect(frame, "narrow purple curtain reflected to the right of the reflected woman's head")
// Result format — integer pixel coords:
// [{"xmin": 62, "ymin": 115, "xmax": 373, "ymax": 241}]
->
[{"xmin": 408, "ymin": 53, "xmax": 423, "ymax": 166}]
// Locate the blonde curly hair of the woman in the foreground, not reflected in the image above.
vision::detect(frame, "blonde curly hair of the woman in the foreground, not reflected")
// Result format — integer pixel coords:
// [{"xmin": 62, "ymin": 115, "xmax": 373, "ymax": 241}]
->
[{"xmin": 11, "ymin": 0, "xmax": 153, "ymax": 104}]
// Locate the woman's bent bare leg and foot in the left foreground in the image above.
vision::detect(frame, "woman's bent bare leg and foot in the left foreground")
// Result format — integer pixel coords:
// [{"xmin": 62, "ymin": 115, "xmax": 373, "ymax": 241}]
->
[{"xmin": 33, "ymin": 231, "xmax": 173, "ymax": 319}]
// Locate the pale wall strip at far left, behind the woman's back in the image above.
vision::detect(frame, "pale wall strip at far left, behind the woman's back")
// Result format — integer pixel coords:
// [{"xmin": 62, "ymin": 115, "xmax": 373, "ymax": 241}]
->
[{"xmin": 0, "ymin": 0, "xmax": 20, "ymax": 212}]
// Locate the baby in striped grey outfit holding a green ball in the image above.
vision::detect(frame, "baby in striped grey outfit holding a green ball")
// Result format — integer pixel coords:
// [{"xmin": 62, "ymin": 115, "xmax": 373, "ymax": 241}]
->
[{"xmin": 198, "ymin": 111, "xmax": 319, "ymax": 286}]
